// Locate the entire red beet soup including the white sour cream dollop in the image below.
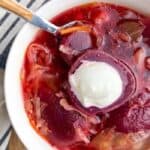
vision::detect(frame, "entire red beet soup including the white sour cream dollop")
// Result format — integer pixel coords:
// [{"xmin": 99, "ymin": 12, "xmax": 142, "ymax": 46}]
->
[{"xmin": 21, "ymin": 3, "xmax": 150, "ymax": 150}]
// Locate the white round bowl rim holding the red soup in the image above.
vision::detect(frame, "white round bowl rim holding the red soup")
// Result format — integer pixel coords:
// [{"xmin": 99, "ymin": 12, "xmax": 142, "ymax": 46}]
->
[{"xmin": 5, "ymin": 0, "xmax": 150, "ymax": 150}]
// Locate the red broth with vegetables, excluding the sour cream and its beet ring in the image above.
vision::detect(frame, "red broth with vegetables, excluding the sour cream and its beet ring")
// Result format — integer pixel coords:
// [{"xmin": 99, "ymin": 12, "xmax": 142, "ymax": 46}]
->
[{"xmin": 21, "ymin": 3, "xmax": 150, "ymax": 150}]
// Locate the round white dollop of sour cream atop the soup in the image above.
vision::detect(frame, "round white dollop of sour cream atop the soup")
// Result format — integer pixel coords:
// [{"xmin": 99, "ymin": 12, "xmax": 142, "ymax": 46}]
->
[{"xmin": 69, "ymin": 61, "xmax": 123, "ymax": 108}]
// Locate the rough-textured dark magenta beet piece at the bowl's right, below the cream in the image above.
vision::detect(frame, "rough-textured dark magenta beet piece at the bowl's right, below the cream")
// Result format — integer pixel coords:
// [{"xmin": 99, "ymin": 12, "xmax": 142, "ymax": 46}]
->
[{"xmin": 108, "ymin": 91, "xmax": 150, "ymax": 133}]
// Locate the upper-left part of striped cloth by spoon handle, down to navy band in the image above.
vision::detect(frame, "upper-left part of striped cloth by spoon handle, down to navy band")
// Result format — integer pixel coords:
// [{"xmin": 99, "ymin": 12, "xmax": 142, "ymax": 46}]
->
[{"xmin": 0, "ymin": 0, "xmax": 49, "ymax": 68}]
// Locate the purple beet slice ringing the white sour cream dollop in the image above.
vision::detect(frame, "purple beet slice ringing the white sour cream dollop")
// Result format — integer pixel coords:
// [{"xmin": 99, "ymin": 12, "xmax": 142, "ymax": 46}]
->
[{"xmin": 68, "ymin": 50, "xmax": 136, "ymax": 114}]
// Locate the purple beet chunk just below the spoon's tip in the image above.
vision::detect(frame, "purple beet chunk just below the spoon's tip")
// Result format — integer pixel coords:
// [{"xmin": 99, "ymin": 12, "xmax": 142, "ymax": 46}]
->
[{"xmin": 59, "ymin": 31, "xmax": 93, "ymax": 63}]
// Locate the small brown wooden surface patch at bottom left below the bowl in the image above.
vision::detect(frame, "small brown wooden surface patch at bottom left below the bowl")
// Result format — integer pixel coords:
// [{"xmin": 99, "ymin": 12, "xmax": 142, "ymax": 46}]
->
[{"xmin": 8, "ymin": 131, "xmax": 26, "ymax": 150}]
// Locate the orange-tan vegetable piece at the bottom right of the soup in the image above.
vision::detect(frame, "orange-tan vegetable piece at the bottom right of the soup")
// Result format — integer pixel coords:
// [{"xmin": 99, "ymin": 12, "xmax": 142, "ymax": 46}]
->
[{"xmin": 91, "ymin": 128, "xmax": 150, "ymax": 150}]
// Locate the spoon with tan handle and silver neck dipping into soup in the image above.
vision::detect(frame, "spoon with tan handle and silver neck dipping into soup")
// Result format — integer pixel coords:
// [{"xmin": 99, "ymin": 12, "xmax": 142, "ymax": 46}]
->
[{"xmin": 0, "ymin": 0, "xmax": 84, "ymax": 35}]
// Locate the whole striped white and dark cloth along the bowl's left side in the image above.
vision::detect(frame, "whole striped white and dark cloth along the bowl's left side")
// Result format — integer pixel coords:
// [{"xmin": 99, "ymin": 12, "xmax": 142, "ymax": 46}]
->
[{"xmin": 0, "ymin": 0, "xmax": 48, "ymax": 150}]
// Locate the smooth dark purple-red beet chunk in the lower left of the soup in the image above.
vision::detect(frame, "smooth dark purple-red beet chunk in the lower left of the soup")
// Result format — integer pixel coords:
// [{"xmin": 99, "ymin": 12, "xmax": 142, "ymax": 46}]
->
[{"xmin": 39, "ymin": 88, "xmax": 77, "ymax": 141}]
